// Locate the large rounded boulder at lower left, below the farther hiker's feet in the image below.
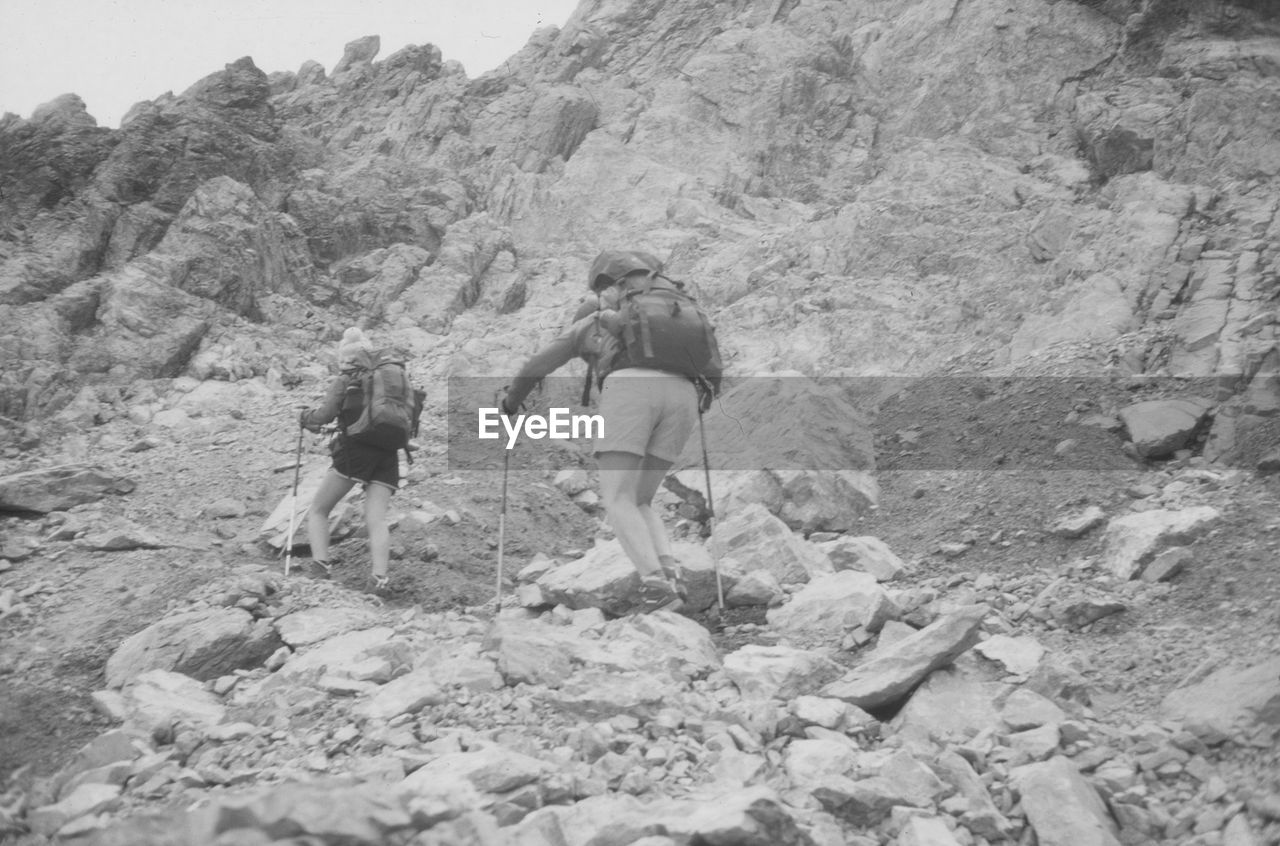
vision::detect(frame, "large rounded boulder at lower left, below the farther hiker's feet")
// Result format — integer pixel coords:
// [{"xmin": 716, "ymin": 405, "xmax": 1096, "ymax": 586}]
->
[{"xmin": 106, "ymin": 608, "xmax": 280, "ymax": 687}]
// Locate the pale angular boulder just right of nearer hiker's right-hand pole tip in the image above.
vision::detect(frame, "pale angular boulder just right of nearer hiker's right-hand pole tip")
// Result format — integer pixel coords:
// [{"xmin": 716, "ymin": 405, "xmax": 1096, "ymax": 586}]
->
[{"xmin": 707, "ymin": 504, "xmax": 835, "ymax": 585}]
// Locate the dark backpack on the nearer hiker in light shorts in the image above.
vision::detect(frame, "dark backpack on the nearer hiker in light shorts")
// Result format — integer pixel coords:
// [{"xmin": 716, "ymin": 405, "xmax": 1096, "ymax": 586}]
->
[{"xmin": 611, "ymin": 274, "xmax": 723, "ymax": 385}]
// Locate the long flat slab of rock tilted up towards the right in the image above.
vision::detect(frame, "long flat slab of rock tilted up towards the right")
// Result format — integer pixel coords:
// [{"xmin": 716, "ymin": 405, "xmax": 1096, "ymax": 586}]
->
[{"xmin": 822, "ymin": 605, "xmax": 988, "ymax": 710}]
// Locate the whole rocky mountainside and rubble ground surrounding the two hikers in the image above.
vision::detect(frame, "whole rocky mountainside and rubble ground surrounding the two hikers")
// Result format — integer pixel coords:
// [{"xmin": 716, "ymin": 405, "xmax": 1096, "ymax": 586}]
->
[{"xmin": 0, "ymin": 0, "xmax": 1280, "ymax": 846}]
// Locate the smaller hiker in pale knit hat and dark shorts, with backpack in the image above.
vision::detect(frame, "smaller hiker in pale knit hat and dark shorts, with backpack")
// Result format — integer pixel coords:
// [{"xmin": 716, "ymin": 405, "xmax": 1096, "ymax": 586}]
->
[{"xmin": 298, "ymin": 328, "xmax": 422, "ymax": 593}]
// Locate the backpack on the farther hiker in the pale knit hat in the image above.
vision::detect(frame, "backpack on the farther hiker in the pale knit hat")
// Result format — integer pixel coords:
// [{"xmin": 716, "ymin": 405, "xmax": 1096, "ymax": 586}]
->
[{"xmin": 343, "ymin": 349, "xmax": 426, "ymax": 462}]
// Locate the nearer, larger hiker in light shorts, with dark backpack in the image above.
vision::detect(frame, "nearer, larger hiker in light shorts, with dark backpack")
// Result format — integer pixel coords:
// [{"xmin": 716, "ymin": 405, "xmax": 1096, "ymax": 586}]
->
[{"xmin": 502, "ymin": 251, "xmax": 722, "ymax": 611}]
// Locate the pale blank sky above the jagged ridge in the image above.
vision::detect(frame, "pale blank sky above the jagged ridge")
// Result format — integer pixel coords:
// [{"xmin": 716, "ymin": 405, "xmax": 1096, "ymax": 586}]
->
[{"xmin": 0, "ymin": 0, "xmax": 577, "ymax": 127}]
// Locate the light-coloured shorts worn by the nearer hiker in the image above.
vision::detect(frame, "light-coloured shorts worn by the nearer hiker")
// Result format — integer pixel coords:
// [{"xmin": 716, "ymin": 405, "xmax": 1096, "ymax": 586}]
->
[{"xmin": 595, "ymin": 367, "xmax": 698, "ymax": 462}]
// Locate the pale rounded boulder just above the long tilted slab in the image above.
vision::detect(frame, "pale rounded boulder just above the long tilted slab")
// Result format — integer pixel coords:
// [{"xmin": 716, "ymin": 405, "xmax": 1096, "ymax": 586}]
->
[{"xmin": 768, "ymin": 570, "xmax": 899, "ymax": 639}]
